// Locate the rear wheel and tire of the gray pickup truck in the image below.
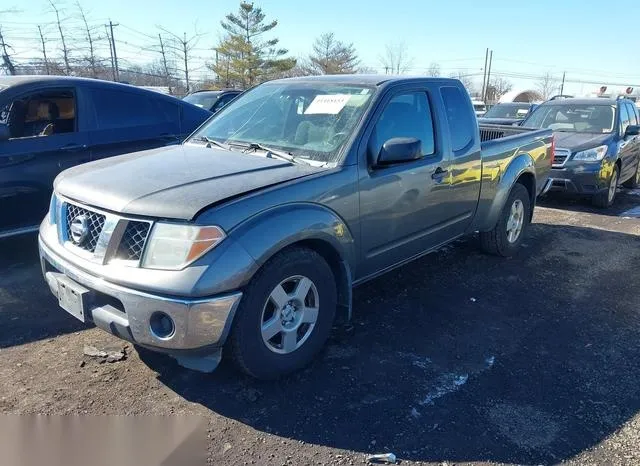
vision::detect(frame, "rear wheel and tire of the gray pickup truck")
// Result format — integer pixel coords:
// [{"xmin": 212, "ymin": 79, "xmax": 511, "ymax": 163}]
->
[{"xmin": 480, "ymin": 183, "xmax": 531, "ymax": 257}]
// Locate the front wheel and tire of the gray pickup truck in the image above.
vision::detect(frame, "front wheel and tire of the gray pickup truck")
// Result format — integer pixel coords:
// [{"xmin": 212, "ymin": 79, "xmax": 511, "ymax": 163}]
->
[{"xmin": 227, "ymin": 247, "xmax": 337, "ymax": 379}]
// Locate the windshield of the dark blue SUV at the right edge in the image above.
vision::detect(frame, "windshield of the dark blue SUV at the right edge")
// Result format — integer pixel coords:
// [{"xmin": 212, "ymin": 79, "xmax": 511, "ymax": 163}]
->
[{"xmin": 524, "ymin": 102, "xmax": 616, "ymax": 133}]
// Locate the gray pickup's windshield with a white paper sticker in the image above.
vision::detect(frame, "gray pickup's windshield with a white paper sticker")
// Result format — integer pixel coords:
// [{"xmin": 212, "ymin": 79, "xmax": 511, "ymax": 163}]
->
[{"xmin": 186, "ymin": 82, "xmax": 374, "ymax": 162}]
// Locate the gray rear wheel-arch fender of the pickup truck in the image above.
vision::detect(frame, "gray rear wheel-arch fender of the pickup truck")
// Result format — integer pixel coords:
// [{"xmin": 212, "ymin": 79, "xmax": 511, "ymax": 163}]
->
[{"xmin": 475, "ymin": 153, "xmax": 536, "ymax": 231}]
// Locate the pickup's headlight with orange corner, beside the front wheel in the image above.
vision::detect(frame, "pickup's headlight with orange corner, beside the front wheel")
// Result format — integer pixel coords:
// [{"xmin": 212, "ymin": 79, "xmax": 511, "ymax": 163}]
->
[{"xmin": 142, "ymin": 223, "xmax": 226, "ymax": 270}]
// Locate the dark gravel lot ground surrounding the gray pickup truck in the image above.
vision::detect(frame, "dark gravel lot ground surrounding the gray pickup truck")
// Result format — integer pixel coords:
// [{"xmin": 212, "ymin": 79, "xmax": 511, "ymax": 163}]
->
[{"xmin": 0, "ymin": 192, "xmax": 640, "ymax": 465}]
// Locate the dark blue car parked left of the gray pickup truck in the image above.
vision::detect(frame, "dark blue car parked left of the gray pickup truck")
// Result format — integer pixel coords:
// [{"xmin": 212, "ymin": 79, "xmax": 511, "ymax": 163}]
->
[{"xmin": 0, "ymin": 76, "xmax": 211, "ymax": 238}]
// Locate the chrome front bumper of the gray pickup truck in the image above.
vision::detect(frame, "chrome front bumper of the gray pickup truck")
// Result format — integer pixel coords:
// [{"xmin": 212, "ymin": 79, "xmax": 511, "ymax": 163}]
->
[{"xmin": 38, "ymin": 236, "xmax": 242, "ymax": 355}]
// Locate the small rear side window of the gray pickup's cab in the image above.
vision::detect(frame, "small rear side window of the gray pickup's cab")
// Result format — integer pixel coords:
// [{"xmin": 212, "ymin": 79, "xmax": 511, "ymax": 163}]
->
[{"xmin": 440, "ymin": 86, "xmax": 477, "ymax": 155}]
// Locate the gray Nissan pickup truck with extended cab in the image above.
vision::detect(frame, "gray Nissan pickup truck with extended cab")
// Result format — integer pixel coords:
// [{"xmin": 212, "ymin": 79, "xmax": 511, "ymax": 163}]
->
[{"xmin": 39, "ymin": 76, "xmax": 553, "ymax": 378}]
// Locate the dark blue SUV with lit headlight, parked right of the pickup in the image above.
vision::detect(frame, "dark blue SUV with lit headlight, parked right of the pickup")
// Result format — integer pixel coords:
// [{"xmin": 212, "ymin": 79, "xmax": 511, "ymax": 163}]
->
[{"xmin": 522, "ymin": 98, "xmax": 640, "ymax": 207}]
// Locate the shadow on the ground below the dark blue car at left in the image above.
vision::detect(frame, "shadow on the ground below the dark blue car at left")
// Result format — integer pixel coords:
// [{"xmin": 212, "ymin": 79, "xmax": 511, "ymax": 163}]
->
[{"xmin": 0, "ymin": 233, "xmax": 87, "ymax": 348}]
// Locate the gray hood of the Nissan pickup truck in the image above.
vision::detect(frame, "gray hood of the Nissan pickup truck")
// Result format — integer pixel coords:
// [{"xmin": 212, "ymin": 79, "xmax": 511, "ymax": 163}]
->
[{"xmin": 54, "ymin": 144, "xmax": 324, "ymax": 220}]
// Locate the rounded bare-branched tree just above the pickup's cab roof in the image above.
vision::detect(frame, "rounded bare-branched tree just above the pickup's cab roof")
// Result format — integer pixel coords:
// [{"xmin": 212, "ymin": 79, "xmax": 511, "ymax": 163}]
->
[{"xmin": 309, "ymin": 32, "xmax": 360, "ymax": 74}]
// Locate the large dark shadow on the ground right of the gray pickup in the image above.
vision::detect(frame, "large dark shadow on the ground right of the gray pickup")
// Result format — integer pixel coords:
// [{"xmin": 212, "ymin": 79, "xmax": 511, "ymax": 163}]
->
[{"xmin": 140, "ymin": 224, "xmax": 640, "ymax": 464}]
